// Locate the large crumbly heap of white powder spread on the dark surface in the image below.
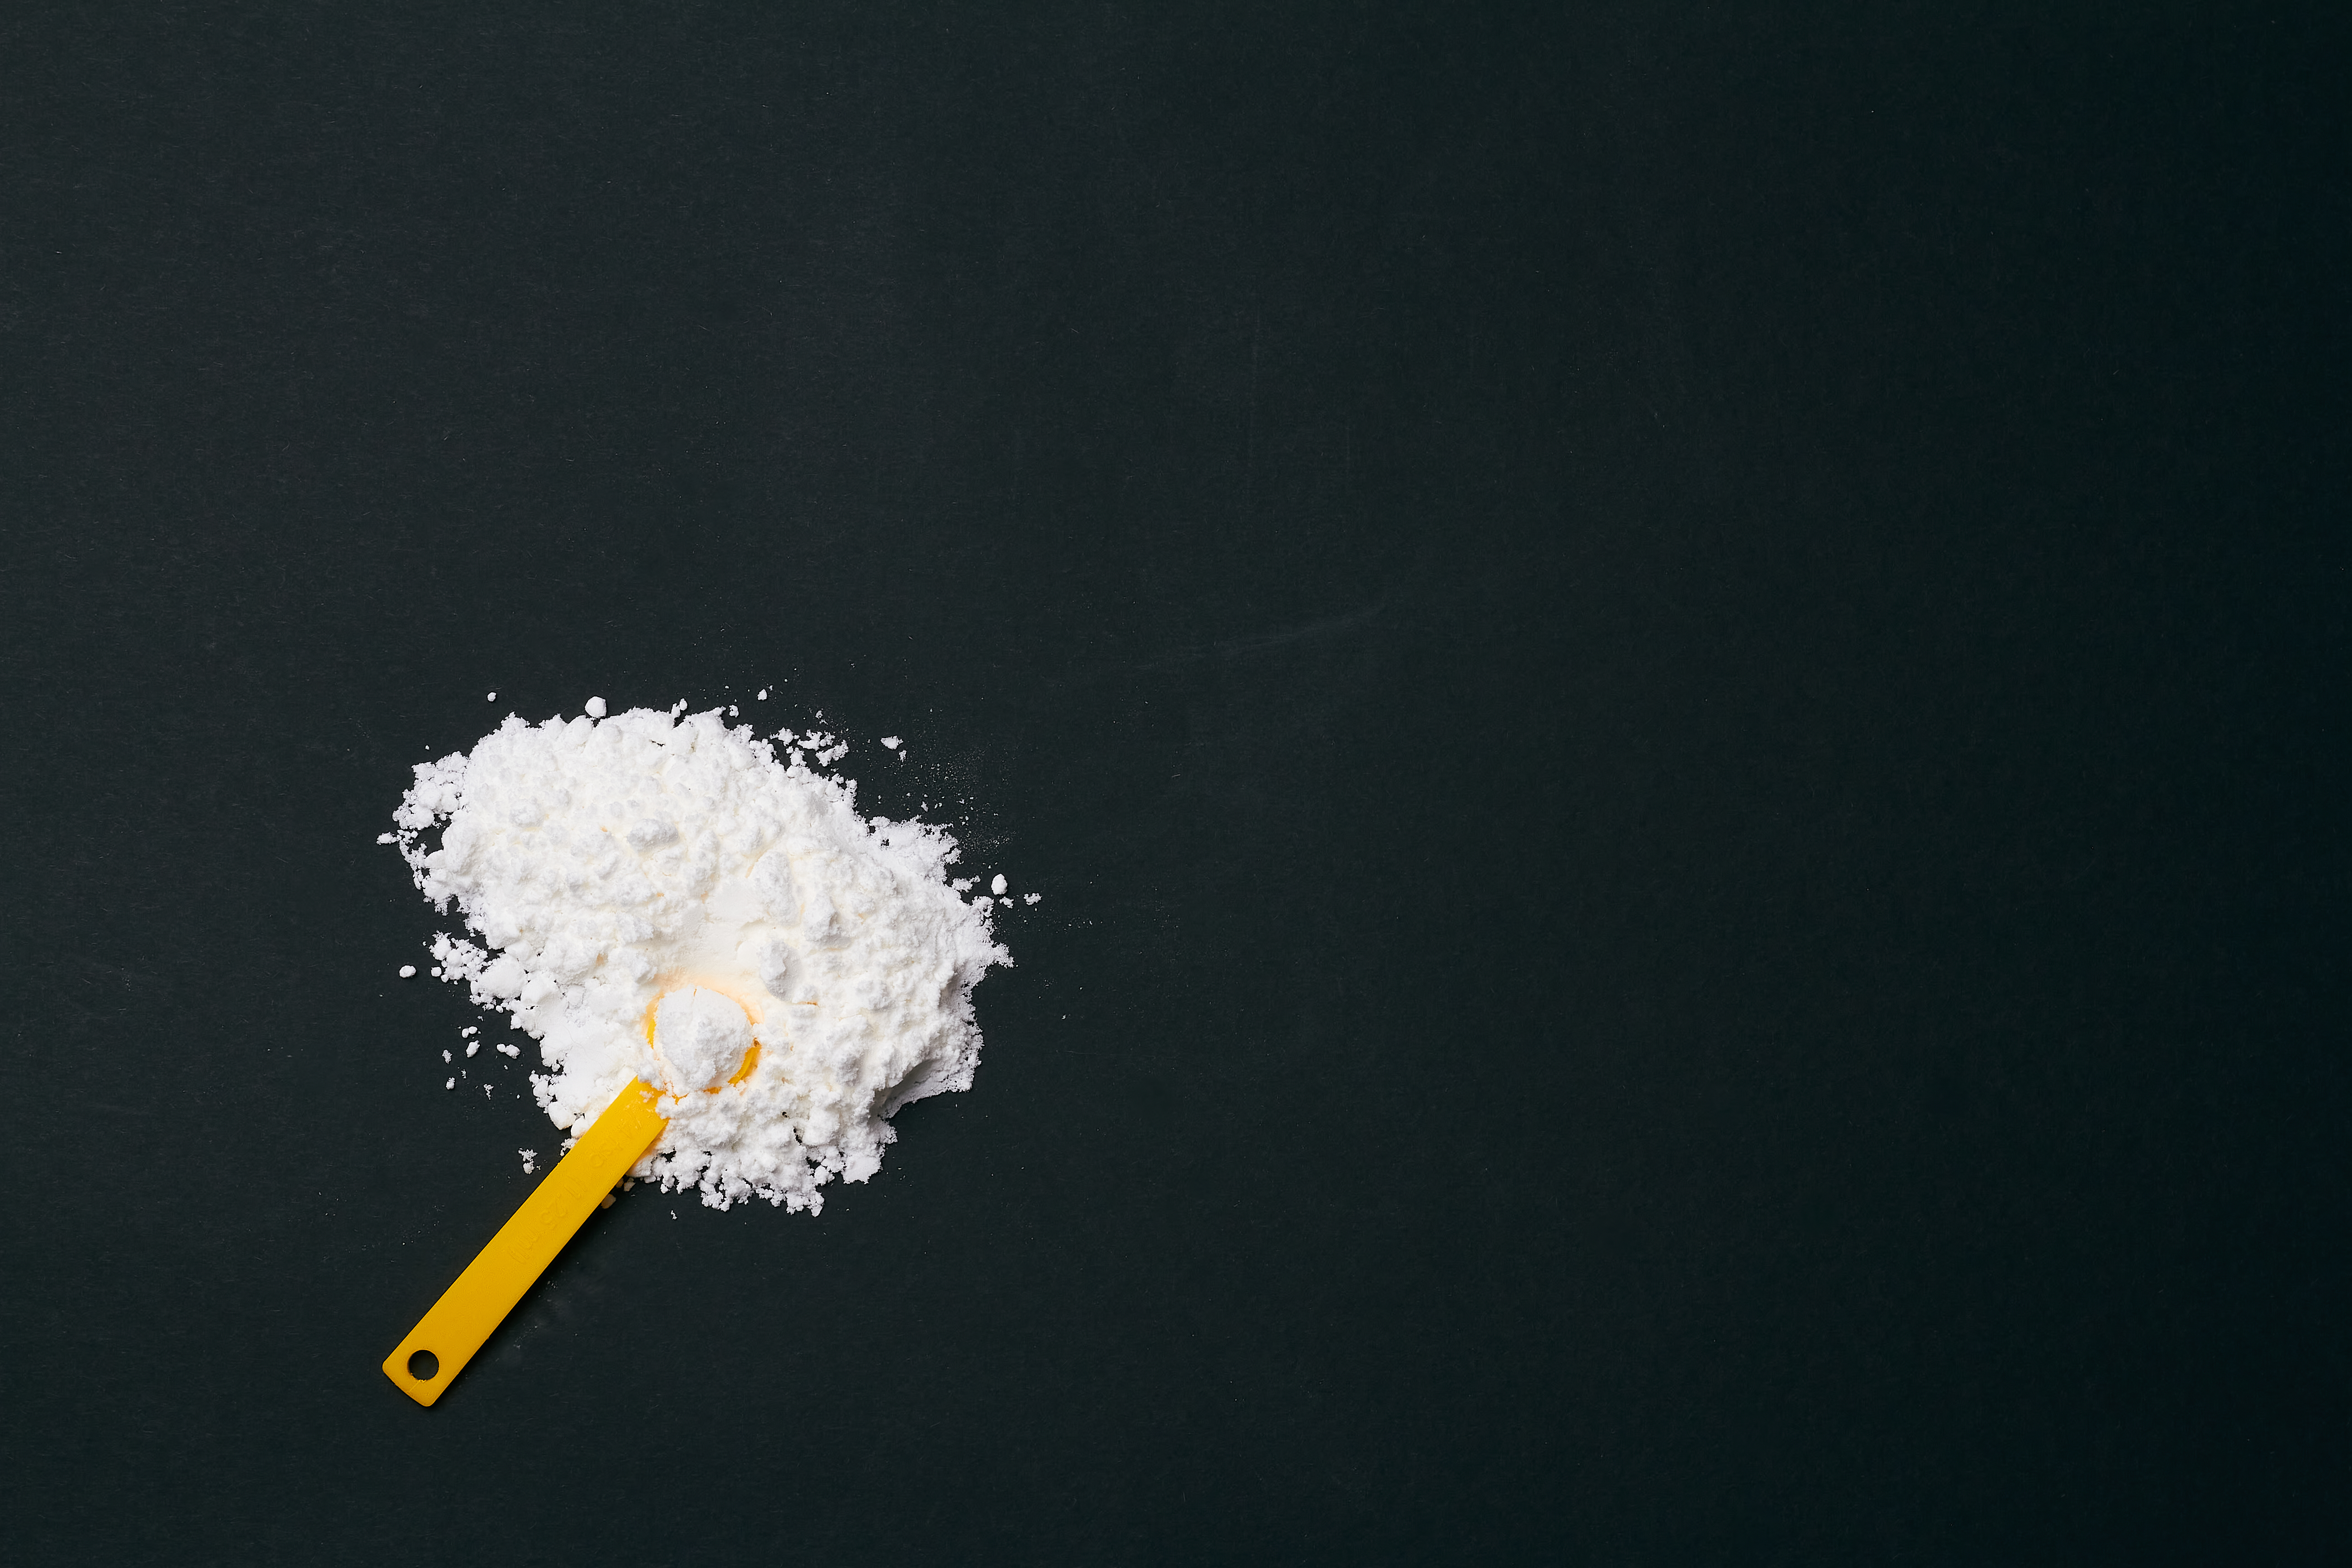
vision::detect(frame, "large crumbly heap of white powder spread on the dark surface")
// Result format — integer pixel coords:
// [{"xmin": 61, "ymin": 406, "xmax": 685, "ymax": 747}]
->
[{"xmin": 393, "ymin": 703, "xmax": 1011, "ymax": 1213}]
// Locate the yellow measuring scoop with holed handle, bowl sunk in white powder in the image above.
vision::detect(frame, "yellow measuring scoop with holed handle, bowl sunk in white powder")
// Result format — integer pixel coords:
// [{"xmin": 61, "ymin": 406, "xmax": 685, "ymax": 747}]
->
[{"xmin": 383, "ymin": 982, "xmax": 760, "ymax": 1406}]
